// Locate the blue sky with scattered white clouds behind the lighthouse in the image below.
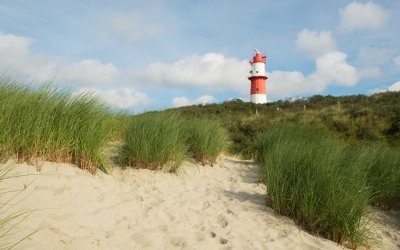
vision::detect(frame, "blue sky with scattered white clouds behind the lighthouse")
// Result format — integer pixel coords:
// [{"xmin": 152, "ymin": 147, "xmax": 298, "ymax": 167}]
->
[{"xmin": 0, "ymin": 0, "xmax": 400, "ymax": 112}]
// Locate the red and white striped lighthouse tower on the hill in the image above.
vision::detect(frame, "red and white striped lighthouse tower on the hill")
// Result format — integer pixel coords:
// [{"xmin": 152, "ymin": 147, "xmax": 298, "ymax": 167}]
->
[{"xmin": 249, "ymin": 49, "xmax": 268, "ymax": 104}]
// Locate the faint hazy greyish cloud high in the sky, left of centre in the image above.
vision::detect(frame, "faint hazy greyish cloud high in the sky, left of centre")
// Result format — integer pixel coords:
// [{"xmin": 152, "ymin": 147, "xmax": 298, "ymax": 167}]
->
[{"xmin": 104, "ymin": 13, "xmax": 165, "ymax": 43}]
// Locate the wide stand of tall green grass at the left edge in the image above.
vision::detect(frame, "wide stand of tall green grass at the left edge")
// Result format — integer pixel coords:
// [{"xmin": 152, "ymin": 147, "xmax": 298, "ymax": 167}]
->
[{"xmin": 0, "ymin": 78, "xmax": 111, "ymax": 173}]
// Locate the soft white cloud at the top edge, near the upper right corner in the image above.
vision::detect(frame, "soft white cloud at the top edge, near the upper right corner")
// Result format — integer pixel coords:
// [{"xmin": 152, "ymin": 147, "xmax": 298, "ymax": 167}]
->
[{"xmin": 339, "ymin": 1, "xmax": 389, "ymax": 33}]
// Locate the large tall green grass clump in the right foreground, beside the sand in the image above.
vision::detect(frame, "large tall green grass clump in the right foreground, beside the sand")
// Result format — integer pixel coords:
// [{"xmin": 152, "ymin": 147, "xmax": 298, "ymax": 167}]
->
[{"xmin": 256, "ymin": 124, "xmax": 370, "ymax": 246}]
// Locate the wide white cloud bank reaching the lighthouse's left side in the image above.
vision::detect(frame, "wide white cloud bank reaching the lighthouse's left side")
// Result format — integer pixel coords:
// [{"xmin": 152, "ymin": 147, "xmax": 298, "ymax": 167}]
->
[{"xmin": 131, "ymin": 53, "xmax": 249, "ymax": 92}]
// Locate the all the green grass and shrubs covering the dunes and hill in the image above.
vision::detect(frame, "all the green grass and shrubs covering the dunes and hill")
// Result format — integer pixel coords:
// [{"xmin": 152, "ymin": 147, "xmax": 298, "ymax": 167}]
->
[{"xmin": 0, "ymin": 77, "xmax": 400, "ymax": 247}]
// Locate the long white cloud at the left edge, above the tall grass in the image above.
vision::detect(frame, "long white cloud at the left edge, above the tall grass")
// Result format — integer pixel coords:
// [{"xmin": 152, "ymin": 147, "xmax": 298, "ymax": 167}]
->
[{"xmin": 0, "ymin": 33, "xmax": 119, "ymax": 85}]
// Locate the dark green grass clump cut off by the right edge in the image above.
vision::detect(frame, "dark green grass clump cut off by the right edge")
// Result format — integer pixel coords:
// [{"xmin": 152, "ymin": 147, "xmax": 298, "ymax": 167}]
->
[{"xmin": 366, "ymin": 145, "xmax": 400, "ymax": 209}]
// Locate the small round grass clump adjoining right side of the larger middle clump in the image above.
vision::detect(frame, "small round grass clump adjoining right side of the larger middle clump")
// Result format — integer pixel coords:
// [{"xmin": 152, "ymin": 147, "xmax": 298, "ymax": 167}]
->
[{"xmin": 185, "ymin": 118, "xmax": 229, "ymax": 165}]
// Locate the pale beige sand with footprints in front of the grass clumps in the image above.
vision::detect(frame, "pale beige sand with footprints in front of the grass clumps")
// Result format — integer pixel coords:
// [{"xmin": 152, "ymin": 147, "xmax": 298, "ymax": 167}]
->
[{"xmin": 2, "ymin": 156, "xmax": 400, "ymax": 249}]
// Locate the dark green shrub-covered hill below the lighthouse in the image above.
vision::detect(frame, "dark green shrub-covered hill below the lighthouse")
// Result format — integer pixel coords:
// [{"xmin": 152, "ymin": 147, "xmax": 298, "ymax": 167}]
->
[{"xmin": 167, "ymin": 92, "xmax": 400, "ymax": 158}]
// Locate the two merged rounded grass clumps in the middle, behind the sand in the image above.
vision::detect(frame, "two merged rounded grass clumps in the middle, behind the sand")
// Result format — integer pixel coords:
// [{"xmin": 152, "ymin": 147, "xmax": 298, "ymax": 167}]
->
[{"xmin": 121, "ymin": 112, "xmax": 228, "ymax": 172}]
